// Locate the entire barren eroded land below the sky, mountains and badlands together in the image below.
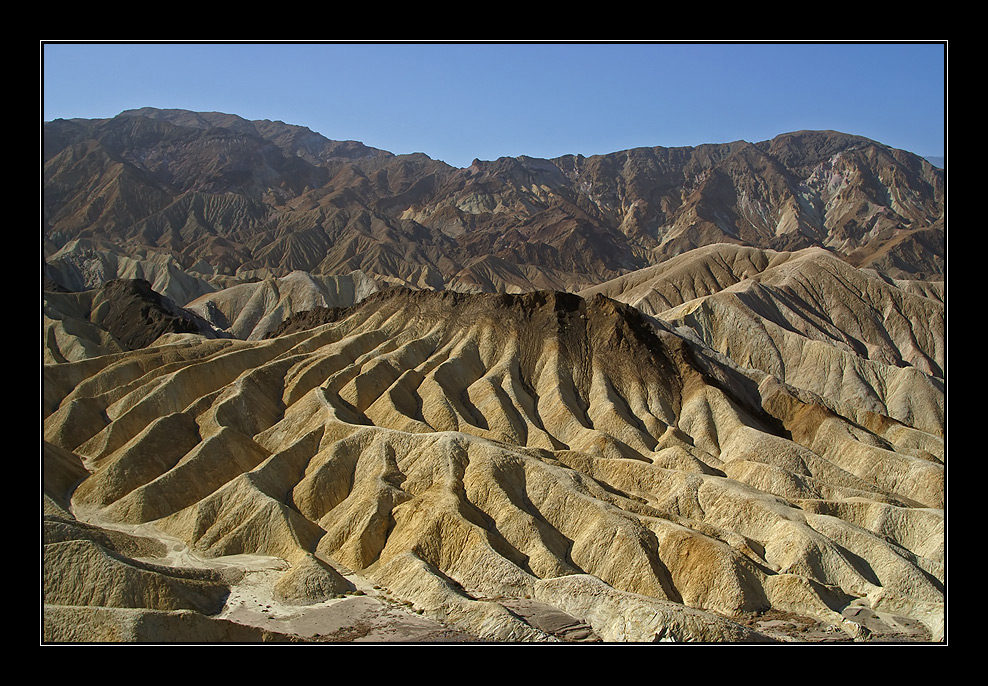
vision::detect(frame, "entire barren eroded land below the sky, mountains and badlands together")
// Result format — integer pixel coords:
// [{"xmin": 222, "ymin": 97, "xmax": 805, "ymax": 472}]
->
[{"xmin": 42, "ymin": 108, "xmax": 946, "ymax": 642}]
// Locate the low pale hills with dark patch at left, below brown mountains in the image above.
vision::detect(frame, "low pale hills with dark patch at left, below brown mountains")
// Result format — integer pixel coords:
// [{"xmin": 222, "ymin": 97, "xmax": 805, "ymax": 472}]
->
[{"xmin": 42, "ymin": 249, "xmax": 381, "ymax": 352}]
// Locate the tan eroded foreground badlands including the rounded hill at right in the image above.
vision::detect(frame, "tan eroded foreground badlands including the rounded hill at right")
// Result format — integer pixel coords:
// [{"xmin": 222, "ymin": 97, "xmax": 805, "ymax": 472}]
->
[{"xmin": 42, "ymin": 246, "xmax": 946, "ymax": 643}]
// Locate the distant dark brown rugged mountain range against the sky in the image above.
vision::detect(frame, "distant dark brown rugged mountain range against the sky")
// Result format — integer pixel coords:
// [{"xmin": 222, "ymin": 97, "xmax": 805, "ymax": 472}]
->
[{"xmin": 44, "ymin": 109, "xmax": 944, "ymax": 292}]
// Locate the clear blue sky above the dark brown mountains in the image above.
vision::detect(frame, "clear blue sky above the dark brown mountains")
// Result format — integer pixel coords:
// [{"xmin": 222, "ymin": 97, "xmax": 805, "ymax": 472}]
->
[{"xmin": 41, "ymin": 42, "xmax": 946, "ymax": 167}]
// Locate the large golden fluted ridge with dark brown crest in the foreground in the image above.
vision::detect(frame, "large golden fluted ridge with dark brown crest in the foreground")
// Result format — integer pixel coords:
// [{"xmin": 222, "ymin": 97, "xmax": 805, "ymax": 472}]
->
[{"xmin": 43, "ymin": 282, "xmax": 945, "ymax": 641}]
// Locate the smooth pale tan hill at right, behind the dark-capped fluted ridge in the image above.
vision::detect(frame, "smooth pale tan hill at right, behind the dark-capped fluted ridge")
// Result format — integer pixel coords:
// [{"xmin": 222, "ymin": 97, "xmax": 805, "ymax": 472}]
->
[{"xmin": 583, "ymin": 245, "xmax": 946, "ymax": 436}]
